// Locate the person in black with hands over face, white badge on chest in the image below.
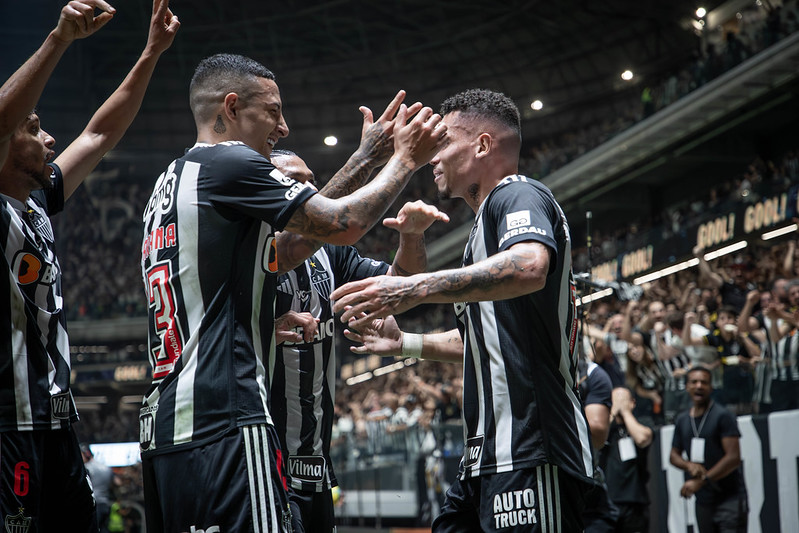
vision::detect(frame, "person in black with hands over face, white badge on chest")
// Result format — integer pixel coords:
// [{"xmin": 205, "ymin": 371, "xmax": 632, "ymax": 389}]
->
[{"xmin": 599, "ymin": 387, "xmax": 654, "ymax": 533}]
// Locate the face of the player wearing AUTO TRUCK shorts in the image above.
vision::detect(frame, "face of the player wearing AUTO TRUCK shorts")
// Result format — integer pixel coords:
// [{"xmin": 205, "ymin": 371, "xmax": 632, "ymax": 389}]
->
[{"xmin": 430, "ymin": 111, "xmax": 477, "ymax": 199}]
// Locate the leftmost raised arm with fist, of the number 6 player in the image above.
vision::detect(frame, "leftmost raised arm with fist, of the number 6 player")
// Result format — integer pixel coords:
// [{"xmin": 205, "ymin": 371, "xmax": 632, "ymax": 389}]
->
[{"xmin": 0, "ymin": 0, "xmax": 116, "ymax": 167}]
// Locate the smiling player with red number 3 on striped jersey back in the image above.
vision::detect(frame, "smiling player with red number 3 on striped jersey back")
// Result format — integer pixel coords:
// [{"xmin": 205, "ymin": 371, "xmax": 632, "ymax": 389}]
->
[{"xmin": 140, "ymin": 54, "xmax": 446, "ymax": 532}]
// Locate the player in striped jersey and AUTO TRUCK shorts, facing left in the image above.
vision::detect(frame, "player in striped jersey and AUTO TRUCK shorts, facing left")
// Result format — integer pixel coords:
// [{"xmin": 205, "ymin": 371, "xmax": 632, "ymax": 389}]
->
[{"xmin": 332, "ymin": 89, "xmax": 593, "ymax": 532}]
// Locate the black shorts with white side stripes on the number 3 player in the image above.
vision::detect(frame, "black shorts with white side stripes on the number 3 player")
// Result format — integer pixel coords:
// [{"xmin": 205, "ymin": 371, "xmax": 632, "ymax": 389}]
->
[{"xmin": 142, "ymin": 424, "xmax": 292, "ymax": 533}]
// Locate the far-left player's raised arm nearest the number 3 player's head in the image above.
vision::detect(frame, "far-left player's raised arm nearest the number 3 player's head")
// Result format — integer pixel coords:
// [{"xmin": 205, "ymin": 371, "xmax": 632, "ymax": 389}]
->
[{"xmin": 55, "ymin": 0, "xmax": 180, "ymax": 200}]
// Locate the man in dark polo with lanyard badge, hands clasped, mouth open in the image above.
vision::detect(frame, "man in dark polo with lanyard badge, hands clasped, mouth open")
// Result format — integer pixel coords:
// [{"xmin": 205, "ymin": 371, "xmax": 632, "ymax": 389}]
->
[{"xmin": 671, "ymin": 366, "xmax": 747, "ymax": 533}]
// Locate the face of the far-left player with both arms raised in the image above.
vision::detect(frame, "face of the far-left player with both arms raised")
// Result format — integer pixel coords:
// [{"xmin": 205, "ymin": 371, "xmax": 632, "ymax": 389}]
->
[{"xmin": 3, "ymin": 113, "xmax": 55, "ymax": 190}]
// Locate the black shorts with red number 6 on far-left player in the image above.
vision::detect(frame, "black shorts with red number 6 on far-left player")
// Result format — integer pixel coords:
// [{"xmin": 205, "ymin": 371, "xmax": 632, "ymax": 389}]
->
[{"xmin": 0, "ymin": 428, "xmax": 97, "ymax": 533}]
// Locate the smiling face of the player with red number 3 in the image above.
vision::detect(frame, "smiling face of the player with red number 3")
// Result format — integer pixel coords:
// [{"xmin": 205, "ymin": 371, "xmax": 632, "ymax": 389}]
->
[{"xmin": 240, "ymin": 78, "xmax": 289, "ymax": 157}]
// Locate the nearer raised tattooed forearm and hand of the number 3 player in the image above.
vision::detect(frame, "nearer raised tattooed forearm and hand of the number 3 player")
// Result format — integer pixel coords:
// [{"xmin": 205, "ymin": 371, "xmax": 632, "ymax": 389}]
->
[{"xmin": 285, "ymin": 104, "xmax": 446, "ymax": 249}]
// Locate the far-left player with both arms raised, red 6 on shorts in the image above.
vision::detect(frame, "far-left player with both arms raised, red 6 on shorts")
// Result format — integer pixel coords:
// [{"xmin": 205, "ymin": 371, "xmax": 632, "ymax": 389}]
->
[{"xmin": 0, "ymin": 0, "xmax": 178, "ymax": 532}]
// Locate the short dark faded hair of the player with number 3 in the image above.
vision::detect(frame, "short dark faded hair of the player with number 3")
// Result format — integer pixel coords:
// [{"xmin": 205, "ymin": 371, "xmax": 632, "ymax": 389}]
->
[{"xmin": 189, "ymin": 54, "xmax": 275, "ymax": 123}]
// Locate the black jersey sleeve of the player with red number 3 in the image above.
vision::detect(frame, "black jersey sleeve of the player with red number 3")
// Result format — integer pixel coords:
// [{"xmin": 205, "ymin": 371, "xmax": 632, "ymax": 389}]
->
[{"xmin": 205, "ymin": 145, "xmax": 316, "ymax": 230}]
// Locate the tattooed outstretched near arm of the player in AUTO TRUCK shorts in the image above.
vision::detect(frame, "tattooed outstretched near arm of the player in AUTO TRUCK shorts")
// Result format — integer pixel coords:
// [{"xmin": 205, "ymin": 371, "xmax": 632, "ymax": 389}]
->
[{"xmin": 330, "ymin": 241, "xmax": 551, "ymax": 329}]
